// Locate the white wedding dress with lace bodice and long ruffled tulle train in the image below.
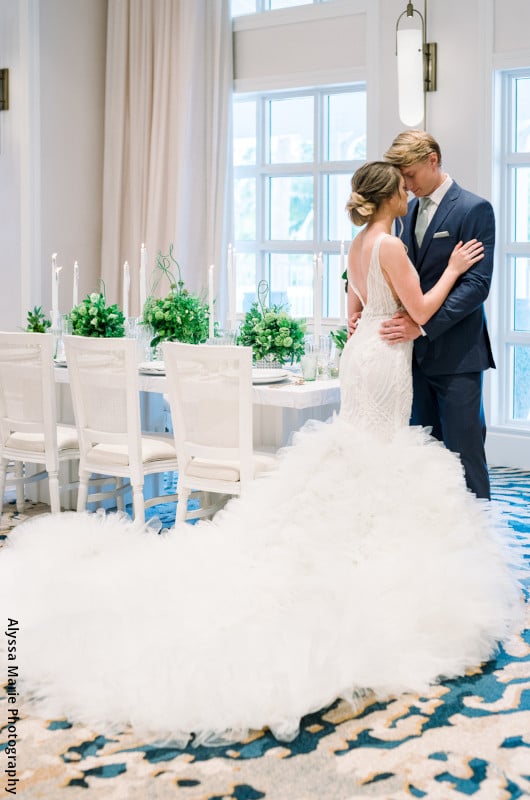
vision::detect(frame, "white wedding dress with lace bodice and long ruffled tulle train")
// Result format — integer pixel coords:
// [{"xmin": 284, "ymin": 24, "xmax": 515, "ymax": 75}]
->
[{"xmin": 0, "ymin": 231, "xmax": 521, "ymax": 744}]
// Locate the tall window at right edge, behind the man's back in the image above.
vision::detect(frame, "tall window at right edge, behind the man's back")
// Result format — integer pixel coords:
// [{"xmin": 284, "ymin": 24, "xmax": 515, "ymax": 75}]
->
[{"xmin": 496, "ymin": 70, "xmax": 530, "ymax": 428}]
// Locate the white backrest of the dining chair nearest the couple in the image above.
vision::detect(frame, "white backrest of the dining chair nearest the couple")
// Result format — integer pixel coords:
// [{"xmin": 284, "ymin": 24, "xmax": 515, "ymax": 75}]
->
[{"xmin": 162, "ymin": 342, "xmax": 253, "ymax": 483}]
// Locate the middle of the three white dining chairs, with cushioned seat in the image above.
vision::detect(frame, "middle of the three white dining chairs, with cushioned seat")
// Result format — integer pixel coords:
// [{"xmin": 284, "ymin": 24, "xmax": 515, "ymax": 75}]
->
[{"xmin": 64, "ymin": 336, "xmax": 177, "ymax": 522}]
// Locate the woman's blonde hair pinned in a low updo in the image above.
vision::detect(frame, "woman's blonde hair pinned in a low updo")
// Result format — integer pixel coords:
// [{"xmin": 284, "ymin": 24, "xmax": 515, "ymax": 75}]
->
[{"xmin": 346, "ymin": 161, "xmax": 401, "ymax": 226}]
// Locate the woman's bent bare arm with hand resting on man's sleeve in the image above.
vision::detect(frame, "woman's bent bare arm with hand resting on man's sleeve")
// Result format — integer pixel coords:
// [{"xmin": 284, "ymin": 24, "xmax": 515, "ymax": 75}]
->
[{"xmin": 379, "ymin": 237, "xmax": 484, "ymax": 325}]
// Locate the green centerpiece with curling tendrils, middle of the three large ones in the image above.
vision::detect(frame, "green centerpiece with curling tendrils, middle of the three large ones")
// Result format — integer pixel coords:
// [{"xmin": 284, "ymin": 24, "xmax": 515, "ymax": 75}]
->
[{"xmin": 142, "ymin": 245, "xmax": 210, "ymax": 347}]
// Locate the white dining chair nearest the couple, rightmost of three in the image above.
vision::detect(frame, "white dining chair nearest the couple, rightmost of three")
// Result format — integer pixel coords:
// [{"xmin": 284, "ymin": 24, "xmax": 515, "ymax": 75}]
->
[{"xmin": 162, "ymin": 342, "xmax": 276, "ymax": 521}]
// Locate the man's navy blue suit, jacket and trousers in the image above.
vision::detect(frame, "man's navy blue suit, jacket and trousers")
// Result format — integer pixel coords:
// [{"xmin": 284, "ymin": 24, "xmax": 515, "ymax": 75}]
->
[{"xmin": 401, "ymin": 182, "xmax": 495, "ymax": 498}]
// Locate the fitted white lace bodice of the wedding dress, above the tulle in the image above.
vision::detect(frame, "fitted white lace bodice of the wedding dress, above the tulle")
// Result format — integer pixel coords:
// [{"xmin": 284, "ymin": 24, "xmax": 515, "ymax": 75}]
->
[{"xmin": 340, "ymin": 233, "xmax": 414, "ymax": 438}]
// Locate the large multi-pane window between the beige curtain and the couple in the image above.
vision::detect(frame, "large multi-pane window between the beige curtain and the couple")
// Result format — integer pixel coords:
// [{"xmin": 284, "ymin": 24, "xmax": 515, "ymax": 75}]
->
[{"xmin": 233, "ymin": 84, "xmax": 366, "ymax": 321}]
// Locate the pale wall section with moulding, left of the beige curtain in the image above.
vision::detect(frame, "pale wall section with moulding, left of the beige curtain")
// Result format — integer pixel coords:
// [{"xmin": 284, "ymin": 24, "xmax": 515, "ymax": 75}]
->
[{"xmin": 0, "ymin": 0, "xmax": 107, "ymax": 330}]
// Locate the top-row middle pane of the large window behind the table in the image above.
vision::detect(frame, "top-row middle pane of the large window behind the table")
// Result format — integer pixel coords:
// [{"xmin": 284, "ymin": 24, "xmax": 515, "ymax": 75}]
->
[{"xmin": 269, "ymin": 97, "xmax": 314, "ymax": 164}]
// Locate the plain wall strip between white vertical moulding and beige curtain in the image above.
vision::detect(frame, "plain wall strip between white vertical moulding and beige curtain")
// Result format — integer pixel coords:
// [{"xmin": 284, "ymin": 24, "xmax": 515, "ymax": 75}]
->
[{"xmin": 39, "ymin": 0, "xmax": 107, "ymax": 312}]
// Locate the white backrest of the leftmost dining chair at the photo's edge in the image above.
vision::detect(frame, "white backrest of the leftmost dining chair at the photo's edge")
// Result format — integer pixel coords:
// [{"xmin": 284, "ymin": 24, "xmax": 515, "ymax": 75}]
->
[{"xmin": 0, "ymin": 332, "xmax": 57, "ymax": 466}]
